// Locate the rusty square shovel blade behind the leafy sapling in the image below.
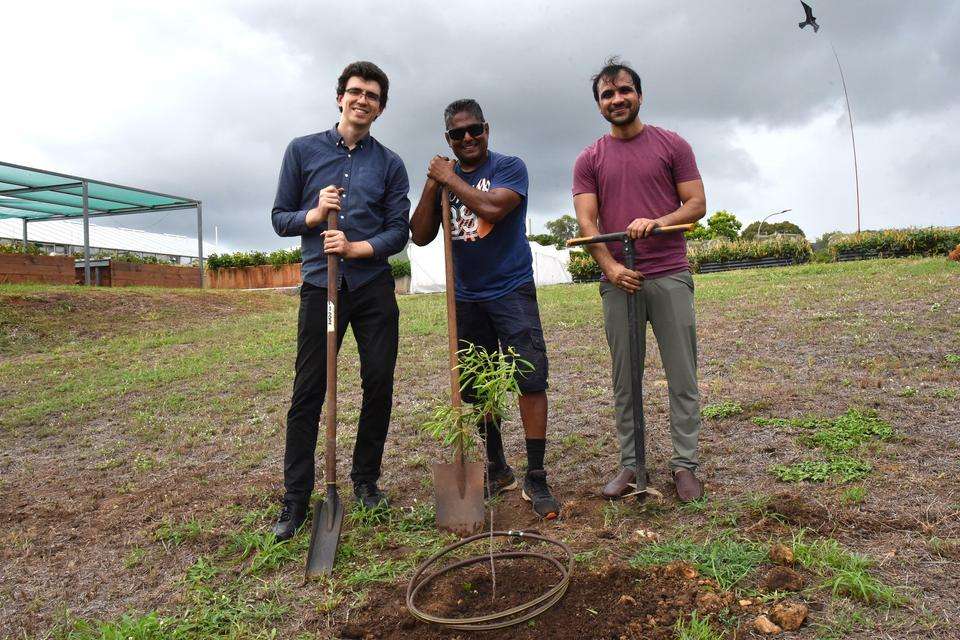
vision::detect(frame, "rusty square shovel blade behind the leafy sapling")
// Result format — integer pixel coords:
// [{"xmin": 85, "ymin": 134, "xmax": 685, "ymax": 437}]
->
[{"xmin": 433, "ymin": 462, "xmax": 484, "ymax": 536}]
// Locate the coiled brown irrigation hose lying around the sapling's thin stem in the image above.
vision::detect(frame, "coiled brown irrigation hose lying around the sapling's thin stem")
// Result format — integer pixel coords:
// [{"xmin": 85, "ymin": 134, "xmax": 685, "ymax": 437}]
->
[{"xmin": 407, "ymin": 531, "xmax": 573, "ymax": 631}]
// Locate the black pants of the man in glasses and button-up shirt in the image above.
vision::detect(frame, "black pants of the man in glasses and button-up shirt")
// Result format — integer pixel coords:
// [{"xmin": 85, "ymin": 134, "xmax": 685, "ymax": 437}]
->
[{"xmin": 283, "ymin": 272, "xmax": 400, "ymax": 503}]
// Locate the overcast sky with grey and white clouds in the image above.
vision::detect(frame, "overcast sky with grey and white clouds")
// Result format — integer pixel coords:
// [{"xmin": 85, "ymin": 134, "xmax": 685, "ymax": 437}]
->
[{"xmin": 0, "ymin": 0, "xmax": 960, "ymax": 250}]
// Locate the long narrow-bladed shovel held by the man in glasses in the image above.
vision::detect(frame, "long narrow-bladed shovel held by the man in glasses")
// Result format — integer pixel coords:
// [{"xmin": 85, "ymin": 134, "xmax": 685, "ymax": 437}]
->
[{"xmin": 305, "ymin": 206, "xmax": 343, "ymax": 580}]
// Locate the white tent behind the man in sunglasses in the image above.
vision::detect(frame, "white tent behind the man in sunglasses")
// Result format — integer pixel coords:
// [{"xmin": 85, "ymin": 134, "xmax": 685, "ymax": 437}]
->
[{"xmin": 407, "ymin": 239, "xmax": 573, "ymax": 293}]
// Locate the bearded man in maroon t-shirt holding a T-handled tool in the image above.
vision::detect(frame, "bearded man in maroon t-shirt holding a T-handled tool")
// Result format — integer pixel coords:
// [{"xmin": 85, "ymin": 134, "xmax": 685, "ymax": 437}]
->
[{"xmin": 573, "ymin": 58, "xmax": 706, "ymax": 502}]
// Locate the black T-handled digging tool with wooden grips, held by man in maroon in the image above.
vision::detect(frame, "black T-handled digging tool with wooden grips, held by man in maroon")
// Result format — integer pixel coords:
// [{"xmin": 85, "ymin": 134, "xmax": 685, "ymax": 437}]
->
[{"xmin": 567, "ymin": 224, "xmax": 693, "ymax": 502}]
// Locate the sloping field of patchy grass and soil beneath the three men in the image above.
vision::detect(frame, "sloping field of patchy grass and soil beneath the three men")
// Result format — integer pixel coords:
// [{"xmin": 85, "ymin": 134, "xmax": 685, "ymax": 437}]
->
[{"xmin": 0, "ymin": 258, "xmax": 960, "ymax": 640}]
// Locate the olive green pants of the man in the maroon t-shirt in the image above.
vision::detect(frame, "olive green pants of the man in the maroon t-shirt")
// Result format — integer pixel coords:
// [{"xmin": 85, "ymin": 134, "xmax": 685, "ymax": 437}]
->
[{"xmin": 600, "ymin": 271, "xmax": 700, "ymax": 471}]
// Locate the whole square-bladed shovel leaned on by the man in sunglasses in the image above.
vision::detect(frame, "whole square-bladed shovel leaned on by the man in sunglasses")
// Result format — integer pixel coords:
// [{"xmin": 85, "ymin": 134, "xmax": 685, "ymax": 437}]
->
[{"xmin": 433, "ymin": 189, "xmax": 484, "ymax": 536}]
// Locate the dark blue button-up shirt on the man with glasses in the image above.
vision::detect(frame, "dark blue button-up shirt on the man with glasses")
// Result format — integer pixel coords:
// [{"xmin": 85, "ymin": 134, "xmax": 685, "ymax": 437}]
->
[{"xmin": 272, "ymin": 126, "xmax": 410, "ymax": 290}]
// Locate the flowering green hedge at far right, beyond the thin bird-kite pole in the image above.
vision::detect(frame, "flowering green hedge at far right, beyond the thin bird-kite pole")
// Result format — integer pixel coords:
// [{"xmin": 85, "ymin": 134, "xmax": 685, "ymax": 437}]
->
[{"xmin": 830, "ymin": 227, "xmax": 960, "ymax": 257}]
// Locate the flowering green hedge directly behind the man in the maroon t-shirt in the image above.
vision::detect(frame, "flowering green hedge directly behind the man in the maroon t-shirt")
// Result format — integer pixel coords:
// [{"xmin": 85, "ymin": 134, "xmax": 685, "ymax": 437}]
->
[{"xmin": 567, "ymin": 238, "xmax": 813, "ymax": 281}]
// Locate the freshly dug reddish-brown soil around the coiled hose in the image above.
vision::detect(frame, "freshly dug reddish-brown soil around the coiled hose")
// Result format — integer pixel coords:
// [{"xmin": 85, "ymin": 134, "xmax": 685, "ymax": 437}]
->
[{"xmin": 339, "ymin": 561, "xmax": 749, "ymax": 640}]
